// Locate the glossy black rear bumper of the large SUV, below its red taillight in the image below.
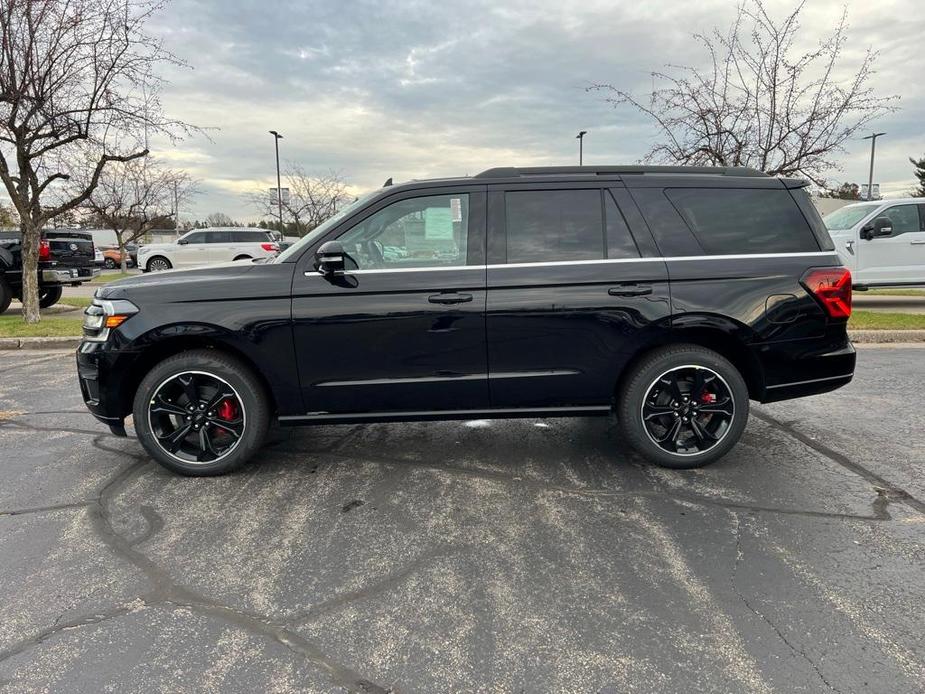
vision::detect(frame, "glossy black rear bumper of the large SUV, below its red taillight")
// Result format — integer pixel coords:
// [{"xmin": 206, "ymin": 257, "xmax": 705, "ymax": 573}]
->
[{"xmin": 758, "ymin": 336, "xmax": 857, "ymax": 402}]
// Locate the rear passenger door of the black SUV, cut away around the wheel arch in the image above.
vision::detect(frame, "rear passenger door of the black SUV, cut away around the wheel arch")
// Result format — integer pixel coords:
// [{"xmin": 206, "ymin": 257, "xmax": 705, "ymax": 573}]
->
[{"xmin": 486, "ymin": 183, "xmax": 670, "ymax": 411}]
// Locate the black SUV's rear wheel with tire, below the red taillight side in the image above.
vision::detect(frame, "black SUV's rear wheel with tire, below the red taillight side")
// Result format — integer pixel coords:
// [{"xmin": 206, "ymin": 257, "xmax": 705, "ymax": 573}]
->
[{"xmin": 616, "ymin": 344, "xmax": 749, "ymax": 469}]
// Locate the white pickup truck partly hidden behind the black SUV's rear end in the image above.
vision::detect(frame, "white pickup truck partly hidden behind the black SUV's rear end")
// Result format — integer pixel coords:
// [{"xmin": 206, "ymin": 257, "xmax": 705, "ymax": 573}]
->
[{"xmin": 824, "ymin": 198, "xmax": 925, "ymax": 289}]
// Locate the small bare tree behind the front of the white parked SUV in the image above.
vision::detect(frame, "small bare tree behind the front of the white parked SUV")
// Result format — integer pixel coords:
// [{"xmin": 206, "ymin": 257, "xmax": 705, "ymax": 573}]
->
[{"xmin": 83, "ymin": 157, "xmax": 197, "ymax": 272}]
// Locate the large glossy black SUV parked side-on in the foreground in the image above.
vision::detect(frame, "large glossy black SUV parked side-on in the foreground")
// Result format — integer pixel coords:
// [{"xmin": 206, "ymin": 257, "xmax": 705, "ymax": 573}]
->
[{"xmin": 77, "ymin": 167, "xmax": 855, "ymax": 475}]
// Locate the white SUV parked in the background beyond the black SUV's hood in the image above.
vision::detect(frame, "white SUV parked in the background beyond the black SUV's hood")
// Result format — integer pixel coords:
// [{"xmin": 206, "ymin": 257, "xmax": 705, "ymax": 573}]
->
[{"xmin": 138, "ymin": 227, "xmax": 279, "ymax": 272}]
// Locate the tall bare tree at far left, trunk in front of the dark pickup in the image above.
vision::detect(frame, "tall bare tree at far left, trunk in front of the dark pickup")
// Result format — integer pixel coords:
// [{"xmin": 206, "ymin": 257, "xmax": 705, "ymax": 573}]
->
[{"xmin": 0, "ymin": 0, "xmax": 190, "ymax": 323}]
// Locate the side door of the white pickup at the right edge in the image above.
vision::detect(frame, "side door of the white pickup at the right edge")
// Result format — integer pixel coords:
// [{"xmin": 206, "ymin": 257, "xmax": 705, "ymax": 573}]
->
[{"xmin": 856, "ymin": 203, "xmax": 925, "ymax": 284}]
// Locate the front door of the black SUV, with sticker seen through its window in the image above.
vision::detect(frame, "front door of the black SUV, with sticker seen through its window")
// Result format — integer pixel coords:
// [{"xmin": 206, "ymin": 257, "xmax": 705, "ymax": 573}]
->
[{"xmin": 292, "ymin": 187, "xmax": 488, "ymax": 418}]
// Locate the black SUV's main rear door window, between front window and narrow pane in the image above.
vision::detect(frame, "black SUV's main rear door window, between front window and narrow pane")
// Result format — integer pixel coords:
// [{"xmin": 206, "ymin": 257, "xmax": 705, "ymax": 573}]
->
[{"xmin": 504, "ymin": 189, "xmax": 605, "ymax": 263}]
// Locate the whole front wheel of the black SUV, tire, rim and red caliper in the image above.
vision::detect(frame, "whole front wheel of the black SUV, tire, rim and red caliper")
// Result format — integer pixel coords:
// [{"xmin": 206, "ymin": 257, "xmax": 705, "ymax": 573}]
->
[{"xmin": 132, "ymin": 349, "xmax": 270, "ymax": 476}]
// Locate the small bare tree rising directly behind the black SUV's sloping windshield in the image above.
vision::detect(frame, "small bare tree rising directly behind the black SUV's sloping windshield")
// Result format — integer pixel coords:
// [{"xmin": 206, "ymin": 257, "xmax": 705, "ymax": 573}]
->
[{"xmin": 248, "ymin": 163, "xmax": 352, "ymax": 236}]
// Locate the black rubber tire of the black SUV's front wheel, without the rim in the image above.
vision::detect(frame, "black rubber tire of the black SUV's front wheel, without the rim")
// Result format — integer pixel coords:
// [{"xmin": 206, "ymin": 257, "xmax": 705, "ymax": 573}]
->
[{"xmin": 132, "ymin": 350, "xmax": 269, "ymax": 476}]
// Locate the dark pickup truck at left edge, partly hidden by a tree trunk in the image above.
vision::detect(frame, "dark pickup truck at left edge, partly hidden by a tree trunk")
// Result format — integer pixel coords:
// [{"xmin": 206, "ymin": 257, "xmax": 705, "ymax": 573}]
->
[{"xmin": 0, "ymin": 229, "xmax": 100, "ymax": 313}]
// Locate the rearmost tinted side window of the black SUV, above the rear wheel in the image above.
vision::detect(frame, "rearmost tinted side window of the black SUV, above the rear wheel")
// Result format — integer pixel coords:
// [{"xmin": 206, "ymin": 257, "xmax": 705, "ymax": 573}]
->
[{"xmin": 665, "ymin": 188, "xmax": 819, "ymax": 255}]
